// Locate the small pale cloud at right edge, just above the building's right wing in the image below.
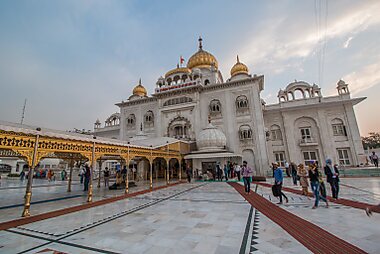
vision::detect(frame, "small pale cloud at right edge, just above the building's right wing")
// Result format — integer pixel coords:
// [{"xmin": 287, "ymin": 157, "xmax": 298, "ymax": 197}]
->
[{"xmin": 343, "ymin": 61, "xmax": 380, "ymax": 95}]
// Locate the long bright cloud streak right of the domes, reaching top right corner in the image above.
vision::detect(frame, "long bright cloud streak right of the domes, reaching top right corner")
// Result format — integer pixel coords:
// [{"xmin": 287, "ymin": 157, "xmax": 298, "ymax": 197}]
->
[{"xmin": 239, "ymin": 2, "xmax": 380, "ymax": 71}]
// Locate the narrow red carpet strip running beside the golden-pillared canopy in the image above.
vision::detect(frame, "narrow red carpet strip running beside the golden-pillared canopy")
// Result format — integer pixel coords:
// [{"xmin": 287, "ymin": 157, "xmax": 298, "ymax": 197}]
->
[{"xmin": 0, "ymin": 182, "xmax": 180, "ymax": 230}]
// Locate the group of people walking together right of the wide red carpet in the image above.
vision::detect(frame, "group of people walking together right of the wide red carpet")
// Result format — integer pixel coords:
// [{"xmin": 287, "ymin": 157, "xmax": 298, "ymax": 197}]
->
[{"xmin": 273, "ymin": 159, "xmax": 339, "ymax": 209}]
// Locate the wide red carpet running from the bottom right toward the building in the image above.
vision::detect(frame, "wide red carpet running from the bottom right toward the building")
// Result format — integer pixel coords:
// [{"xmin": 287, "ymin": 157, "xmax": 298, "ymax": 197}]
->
[{"xmin": 229, "ymin": 183, "xmax": 366, "ymax": 254}]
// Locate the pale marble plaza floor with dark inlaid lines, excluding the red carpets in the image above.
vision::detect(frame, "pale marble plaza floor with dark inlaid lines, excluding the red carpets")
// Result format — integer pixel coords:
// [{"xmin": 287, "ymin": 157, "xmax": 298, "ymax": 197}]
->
[{"xmin": 0, "ymin": 178, "xmax": 380, "ymax": 254}]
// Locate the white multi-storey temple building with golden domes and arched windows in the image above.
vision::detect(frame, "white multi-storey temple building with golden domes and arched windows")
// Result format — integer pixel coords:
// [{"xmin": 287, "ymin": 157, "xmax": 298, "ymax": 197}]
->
[{"xmin": 94, "ymin": 39, "xmax": 364, "ymax": 175}]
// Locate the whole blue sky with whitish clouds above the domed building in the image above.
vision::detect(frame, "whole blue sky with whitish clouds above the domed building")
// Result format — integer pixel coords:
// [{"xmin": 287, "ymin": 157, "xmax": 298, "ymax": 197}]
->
[{"xmin": 0, "ymin": 0, "xmax": 380, "ymax": 135}]
